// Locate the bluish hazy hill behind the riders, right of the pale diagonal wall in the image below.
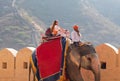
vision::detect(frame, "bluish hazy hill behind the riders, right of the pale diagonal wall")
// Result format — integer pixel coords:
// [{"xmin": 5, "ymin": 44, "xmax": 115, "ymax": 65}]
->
[{"xmin": 18, "ymin": 0, "xmax": 120, "ymax": 47}]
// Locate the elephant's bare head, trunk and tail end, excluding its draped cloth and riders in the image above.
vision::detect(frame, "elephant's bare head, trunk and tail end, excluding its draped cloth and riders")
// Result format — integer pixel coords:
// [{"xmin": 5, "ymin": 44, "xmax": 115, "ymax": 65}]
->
[{"xmin": 29, "ymin": 39, "xmax": 100, "ymax": 81}]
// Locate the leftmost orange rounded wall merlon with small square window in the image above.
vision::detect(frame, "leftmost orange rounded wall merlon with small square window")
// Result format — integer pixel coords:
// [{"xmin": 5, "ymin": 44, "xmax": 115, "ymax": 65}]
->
[{"xmin": 0, "ymin": 48, "xmax": 17, "ymax": 81}]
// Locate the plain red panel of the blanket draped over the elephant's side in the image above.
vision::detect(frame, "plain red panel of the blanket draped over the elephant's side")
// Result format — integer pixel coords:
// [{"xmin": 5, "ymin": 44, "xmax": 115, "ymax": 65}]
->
[{"xmin": 37, "ymin": 38, "xmax": 62, "ymax": 78}]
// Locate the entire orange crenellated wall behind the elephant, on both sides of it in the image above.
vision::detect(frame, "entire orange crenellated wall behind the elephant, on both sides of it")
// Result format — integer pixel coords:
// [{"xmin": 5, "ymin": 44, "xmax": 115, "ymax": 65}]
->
[{"xmin": 0, "ymin": 43, "xmax": 120, "ymax": 81}]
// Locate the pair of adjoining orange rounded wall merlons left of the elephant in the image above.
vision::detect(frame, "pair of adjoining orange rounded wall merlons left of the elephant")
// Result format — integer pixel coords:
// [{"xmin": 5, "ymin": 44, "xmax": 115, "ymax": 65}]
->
[{"xmin": 0, "ymin": 47, "xmax": 34, "ymax": 81}]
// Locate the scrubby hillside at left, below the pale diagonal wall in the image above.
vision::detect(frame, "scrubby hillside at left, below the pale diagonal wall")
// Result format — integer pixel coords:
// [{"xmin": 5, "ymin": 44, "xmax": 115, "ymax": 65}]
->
[{"xmin": 0, "ymin": 0, "xmax": 43, "ymax": 49}]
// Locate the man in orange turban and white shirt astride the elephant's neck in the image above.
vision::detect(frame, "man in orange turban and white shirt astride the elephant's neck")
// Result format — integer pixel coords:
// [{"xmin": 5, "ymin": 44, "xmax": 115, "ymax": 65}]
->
[{"xmin": 71, "ymin": 25, "xmax": 82, "ymax": 46}]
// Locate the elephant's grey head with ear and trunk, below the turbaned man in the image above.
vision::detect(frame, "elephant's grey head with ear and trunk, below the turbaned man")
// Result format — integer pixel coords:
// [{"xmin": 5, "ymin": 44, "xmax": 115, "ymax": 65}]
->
[{"xmin": 66, "ymin": 44, "xmax": 100, "ymax": 81}]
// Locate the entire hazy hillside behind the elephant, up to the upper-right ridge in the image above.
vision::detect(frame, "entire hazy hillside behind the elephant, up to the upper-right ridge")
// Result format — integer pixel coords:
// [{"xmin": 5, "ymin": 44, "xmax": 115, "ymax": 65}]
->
[{"xmin": 0, "ymin": 0, "xmax": 120, "ymax": 49}]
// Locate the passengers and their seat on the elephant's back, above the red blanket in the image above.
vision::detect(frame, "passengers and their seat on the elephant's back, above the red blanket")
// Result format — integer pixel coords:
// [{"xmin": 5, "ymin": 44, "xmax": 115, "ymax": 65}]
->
[{"xmin": 42, "ymin": 20, "xmax": 70, "ymax": 42}]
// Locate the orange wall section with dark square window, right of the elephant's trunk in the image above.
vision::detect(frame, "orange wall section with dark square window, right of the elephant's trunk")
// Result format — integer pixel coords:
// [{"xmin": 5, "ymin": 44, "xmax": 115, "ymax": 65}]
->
[{"xmin": 96, "ymin": 43, "xmax": 120, "ymax": 81}]
